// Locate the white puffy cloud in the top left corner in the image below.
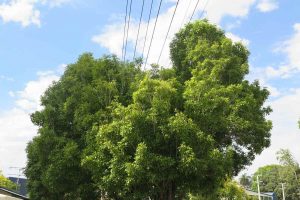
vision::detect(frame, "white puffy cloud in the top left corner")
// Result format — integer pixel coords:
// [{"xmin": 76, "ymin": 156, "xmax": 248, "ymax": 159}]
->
[{"xmin": 0, "ymin": 0, "xmax": 71, "ymax": 27}]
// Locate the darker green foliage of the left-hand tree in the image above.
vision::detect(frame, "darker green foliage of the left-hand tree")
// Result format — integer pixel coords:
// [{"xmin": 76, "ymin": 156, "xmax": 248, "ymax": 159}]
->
[{"xmin": 26, "ymin": 54, "xmax": 139, "ymax": 200}]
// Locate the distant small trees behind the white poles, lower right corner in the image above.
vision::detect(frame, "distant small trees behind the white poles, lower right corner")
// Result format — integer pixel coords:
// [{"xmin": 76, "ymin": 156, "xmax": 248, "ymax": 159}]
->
[{"xmin": 252, "ymin": 149, "xmax": 300, "ymax": 200}]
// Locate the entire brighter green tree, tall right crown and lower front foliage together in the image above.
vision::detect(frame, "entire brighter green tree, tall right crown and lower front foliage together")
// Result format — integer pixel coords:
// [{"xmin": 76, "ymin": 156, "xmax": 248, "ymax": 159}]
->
[{"xmin": 83, "ymin": 21, "xmax": 271, "ymax": 199}]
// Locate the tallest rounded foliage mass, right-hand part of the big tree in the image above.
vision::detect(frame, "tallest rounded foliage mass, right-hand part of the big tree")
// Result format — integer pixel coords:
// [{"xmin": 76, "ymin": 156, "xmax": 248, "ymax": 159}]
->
[{"xmin": 171, "ymin": 21, "xmax": 272, "ymax": 174}]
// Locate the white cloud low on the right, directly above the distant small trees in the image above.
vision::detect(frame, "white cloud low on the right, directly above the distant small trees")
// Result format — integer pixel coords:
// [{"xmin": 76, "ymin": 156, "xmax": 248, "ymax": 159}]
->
[{"xmin": 248, "ymin": 88, "xmax": 300, "ymax": 174}]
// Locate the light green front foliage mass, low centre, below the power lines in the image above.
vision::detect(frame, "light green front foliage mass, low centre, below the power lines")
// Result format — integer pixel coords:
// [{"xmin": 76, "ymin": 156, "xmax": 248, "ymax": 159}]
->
[{"xmin": 84, "ymin": 76, "xmax": 231, "ymax": 199}]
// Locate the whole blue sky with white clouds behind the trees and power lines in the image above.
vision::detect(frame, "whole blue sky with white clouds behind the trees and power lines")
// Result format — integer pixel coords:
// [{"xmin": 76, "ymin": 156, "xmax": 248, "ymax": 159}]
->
[{"xmin": 0, "ymin": 0, "xmax": 300, "ymax": 174}]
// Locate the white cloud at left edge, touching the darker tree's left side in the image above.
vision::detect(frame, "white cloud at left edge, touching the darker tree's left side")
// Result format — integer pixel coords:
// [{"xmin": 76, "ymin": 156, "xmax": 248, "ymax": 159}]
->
[{"xmin": 0, "ymin": 69, "xmax": 59, "ymax": 175}]
